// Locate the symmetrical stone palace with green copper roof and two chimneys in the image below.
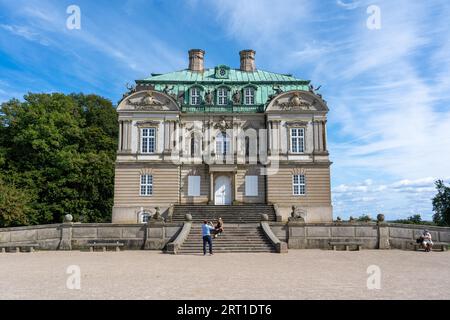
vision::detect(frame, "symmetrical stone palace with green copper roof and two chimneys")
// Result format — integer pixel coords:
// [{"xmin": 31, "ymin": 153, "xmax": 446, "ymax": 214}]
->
[{"xmin": 112, "ymin": 49, "xmax": 332, "ymax": 223}]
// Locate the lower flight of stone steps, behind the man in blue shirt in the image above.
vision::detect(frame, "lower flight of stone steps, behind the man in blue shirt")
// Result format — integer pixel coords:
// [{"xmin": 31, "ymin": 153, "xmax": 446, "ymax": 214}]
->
[{"xmin": 178, "ymin": 224, "xmax": 276, "ymax": 254}]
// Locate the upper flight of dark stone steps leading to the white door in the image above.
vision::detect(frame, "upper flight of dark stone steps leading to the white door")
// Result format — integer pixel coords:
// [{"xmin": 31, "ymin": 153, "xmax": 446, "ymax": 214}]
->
[{"xmin": 172, "ymin": 204, "xmax": 276, "ymax": 222}]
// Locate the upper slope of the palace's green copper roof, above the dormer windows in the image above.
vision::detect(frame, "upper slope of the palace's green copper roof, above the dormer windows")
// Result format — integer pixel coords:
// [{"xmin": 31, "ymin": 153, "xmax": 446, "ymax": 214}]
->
[{"xmin": 138, "ymin": 68, "xmax": 309, "ymax": 84}]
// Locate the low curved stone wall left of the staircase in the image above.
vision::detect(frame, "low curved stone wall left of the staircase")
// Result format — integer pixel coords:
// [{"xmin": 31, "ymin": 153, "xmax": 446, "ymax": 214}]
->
[{"xmin": 0, "ymin": 222, "xmax": 183, "ymax": 250}]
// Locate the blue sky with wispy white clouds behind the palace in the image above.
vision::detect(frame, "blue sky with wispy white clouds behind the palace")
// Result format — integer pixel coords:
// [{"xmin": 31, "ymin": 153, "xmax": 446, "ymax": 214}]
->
[{"xmin": 0, "ymin": 0, "xmax": 450, "ymax": 219}]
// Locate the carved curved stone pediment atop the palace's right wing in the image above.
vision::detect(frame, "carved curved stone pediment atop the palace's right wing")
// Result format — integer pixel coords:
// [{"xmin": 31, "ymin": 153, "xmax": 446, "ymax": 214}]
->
[{"xmin": 266, "ymin": 90, "xmax": 328, "ymax": 112}]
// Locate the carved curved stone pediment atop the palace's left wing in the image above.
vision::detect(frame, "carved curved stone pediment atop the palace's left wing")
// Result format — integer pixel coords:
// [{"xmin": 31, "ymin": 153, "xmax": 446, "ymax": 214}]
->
[{"xmin": 117, "ymin": 90, "xmax": 180, "ymax": 111}]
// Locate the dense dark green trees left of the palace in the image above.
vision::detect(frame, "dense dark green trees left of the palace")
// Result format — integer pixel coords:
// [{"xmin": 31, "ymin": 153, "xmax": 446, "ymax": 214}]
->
[{"xmin": 0, "ymin": 93, "xmax": 118, "ymax": 227}]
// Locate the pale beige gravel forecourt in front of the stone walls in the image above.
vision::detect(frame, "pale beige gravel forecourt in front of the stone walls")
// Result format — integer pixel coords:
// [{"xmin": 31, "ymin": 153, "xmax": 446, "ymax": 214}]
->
[{"xmin": 0, "ymin": 250, "xmax": 450, "ymax": 300}]
